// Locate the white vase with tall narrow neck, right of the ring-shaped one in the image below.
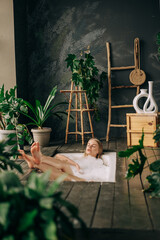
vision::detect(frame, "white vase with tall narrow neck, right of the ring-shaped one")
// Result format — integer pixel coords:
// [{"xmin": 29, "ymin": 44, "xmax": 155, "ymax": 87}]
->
[{"xmin": 143, "ymin": 81, "xmax": 158, "ymax": 113}]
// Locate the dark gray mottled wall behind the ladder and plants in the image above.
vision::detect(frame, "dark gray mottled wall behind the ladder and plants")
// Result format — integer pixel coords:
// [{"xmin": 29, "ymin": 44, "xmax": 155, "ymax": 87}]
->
[{"xmin": 15, "ymin": 0, "xmax": 160, "ymax": 142}]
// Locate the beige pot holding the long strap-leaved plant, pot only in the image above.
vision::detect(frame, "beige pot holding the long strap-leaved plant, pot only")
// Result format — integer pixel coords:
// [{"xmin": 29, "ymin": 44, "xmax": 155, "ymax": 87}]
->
[{"xmin": 31, "ymin": 127, "xmax": 52, "ymax": 147}]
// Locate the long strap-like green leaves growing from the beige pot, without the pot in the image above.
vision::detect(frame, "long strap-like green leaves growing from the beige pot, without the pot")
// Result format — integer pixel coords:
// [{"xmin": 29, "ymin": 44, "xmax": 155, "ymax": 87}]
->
[{"xmin": 21, "ymin": 86, "xmax": 67, "ymax": 129}]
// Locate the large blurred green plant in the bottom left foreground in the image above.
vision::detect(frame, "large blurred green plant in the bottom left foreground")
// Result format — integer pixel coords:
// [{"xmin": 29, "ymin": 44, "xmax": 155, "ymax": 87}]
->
[{"xmin": 0, "ymin": 172, "xmax": 85, "ymax": 240}]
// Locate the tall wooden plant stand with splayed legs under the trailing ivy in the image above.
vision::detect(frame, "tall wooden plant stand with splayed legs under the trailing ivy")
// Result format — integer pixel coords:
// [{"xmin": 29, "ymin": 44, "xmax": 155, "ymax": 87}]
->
[{"xmin": 60, "ymin": 81, "xmax": 94, "ymax": 145}]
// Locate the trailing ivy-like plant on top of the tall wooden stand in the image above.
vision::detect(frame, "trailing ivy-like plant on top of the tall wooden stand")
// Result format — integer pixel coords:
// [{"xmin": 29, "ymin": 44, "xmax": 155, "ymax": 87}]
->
[{"xmin": 65, "ymin": 50, "xmax": 107, "ymax": 105}]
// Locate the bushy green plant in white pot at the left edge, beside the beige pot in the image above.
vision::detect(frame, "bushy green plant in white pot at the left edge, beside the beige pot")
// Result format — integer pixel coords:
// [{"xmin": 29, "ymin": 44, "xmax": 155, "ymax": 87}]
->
[{"xmin": 0, "ymin": 84, "xmax": 32, "ymax": 152}]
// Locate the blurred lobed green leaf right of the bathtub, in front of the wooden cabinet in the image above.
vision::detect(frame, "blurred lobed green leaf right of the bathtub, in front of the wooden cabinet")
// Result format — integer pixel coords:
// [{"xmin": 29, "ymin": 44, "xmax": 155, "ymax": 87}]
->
[{"xmin": 118, "ymin": 133, "xmax": 147, "ymax": 179}]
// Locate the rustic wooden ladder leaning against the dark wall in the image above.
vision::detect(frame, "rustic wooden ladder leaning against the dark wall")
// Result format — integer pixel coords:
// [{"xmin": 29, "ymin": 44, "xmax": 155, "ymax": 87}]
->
[{"xmin": 106, "ymin": 38, "xmax": 140, "ymax": 141}]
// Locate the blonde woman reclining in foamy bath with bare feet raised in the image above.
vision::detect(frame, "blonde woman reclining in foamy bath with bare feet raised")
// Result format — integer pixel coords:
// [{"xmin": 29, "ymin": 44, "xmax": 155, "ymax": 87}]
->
[{"xmin": 19, "ymin": 138, "xmax": 107, "ymax": 181}]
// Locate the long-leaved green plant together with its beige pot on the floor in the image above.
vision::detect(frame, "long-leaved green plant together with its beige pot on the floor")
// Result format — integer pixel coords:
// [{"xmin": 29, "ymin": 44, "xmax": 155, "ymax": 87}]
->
[{"xmin": 22, "ymin": 86, "xmax": 67, "ymax": 147}]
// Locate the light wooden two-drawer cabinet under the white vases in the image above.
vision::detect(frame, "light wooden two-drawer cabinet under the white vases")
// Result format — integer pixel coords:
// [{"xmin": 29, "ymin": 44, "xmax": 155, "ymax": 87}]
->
[{"xmin": 126, "ymin": 113, "xmax": 160, "ymax": 147}]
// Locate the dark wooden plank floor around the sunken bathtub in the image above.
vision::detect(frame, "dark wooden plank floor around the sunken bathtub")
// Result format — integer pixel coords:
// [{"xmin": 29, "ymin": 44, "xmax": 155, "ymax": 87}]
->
[{"xmin": 15, "ymin": 139, "xmax": 160, "ymax": 240}]
